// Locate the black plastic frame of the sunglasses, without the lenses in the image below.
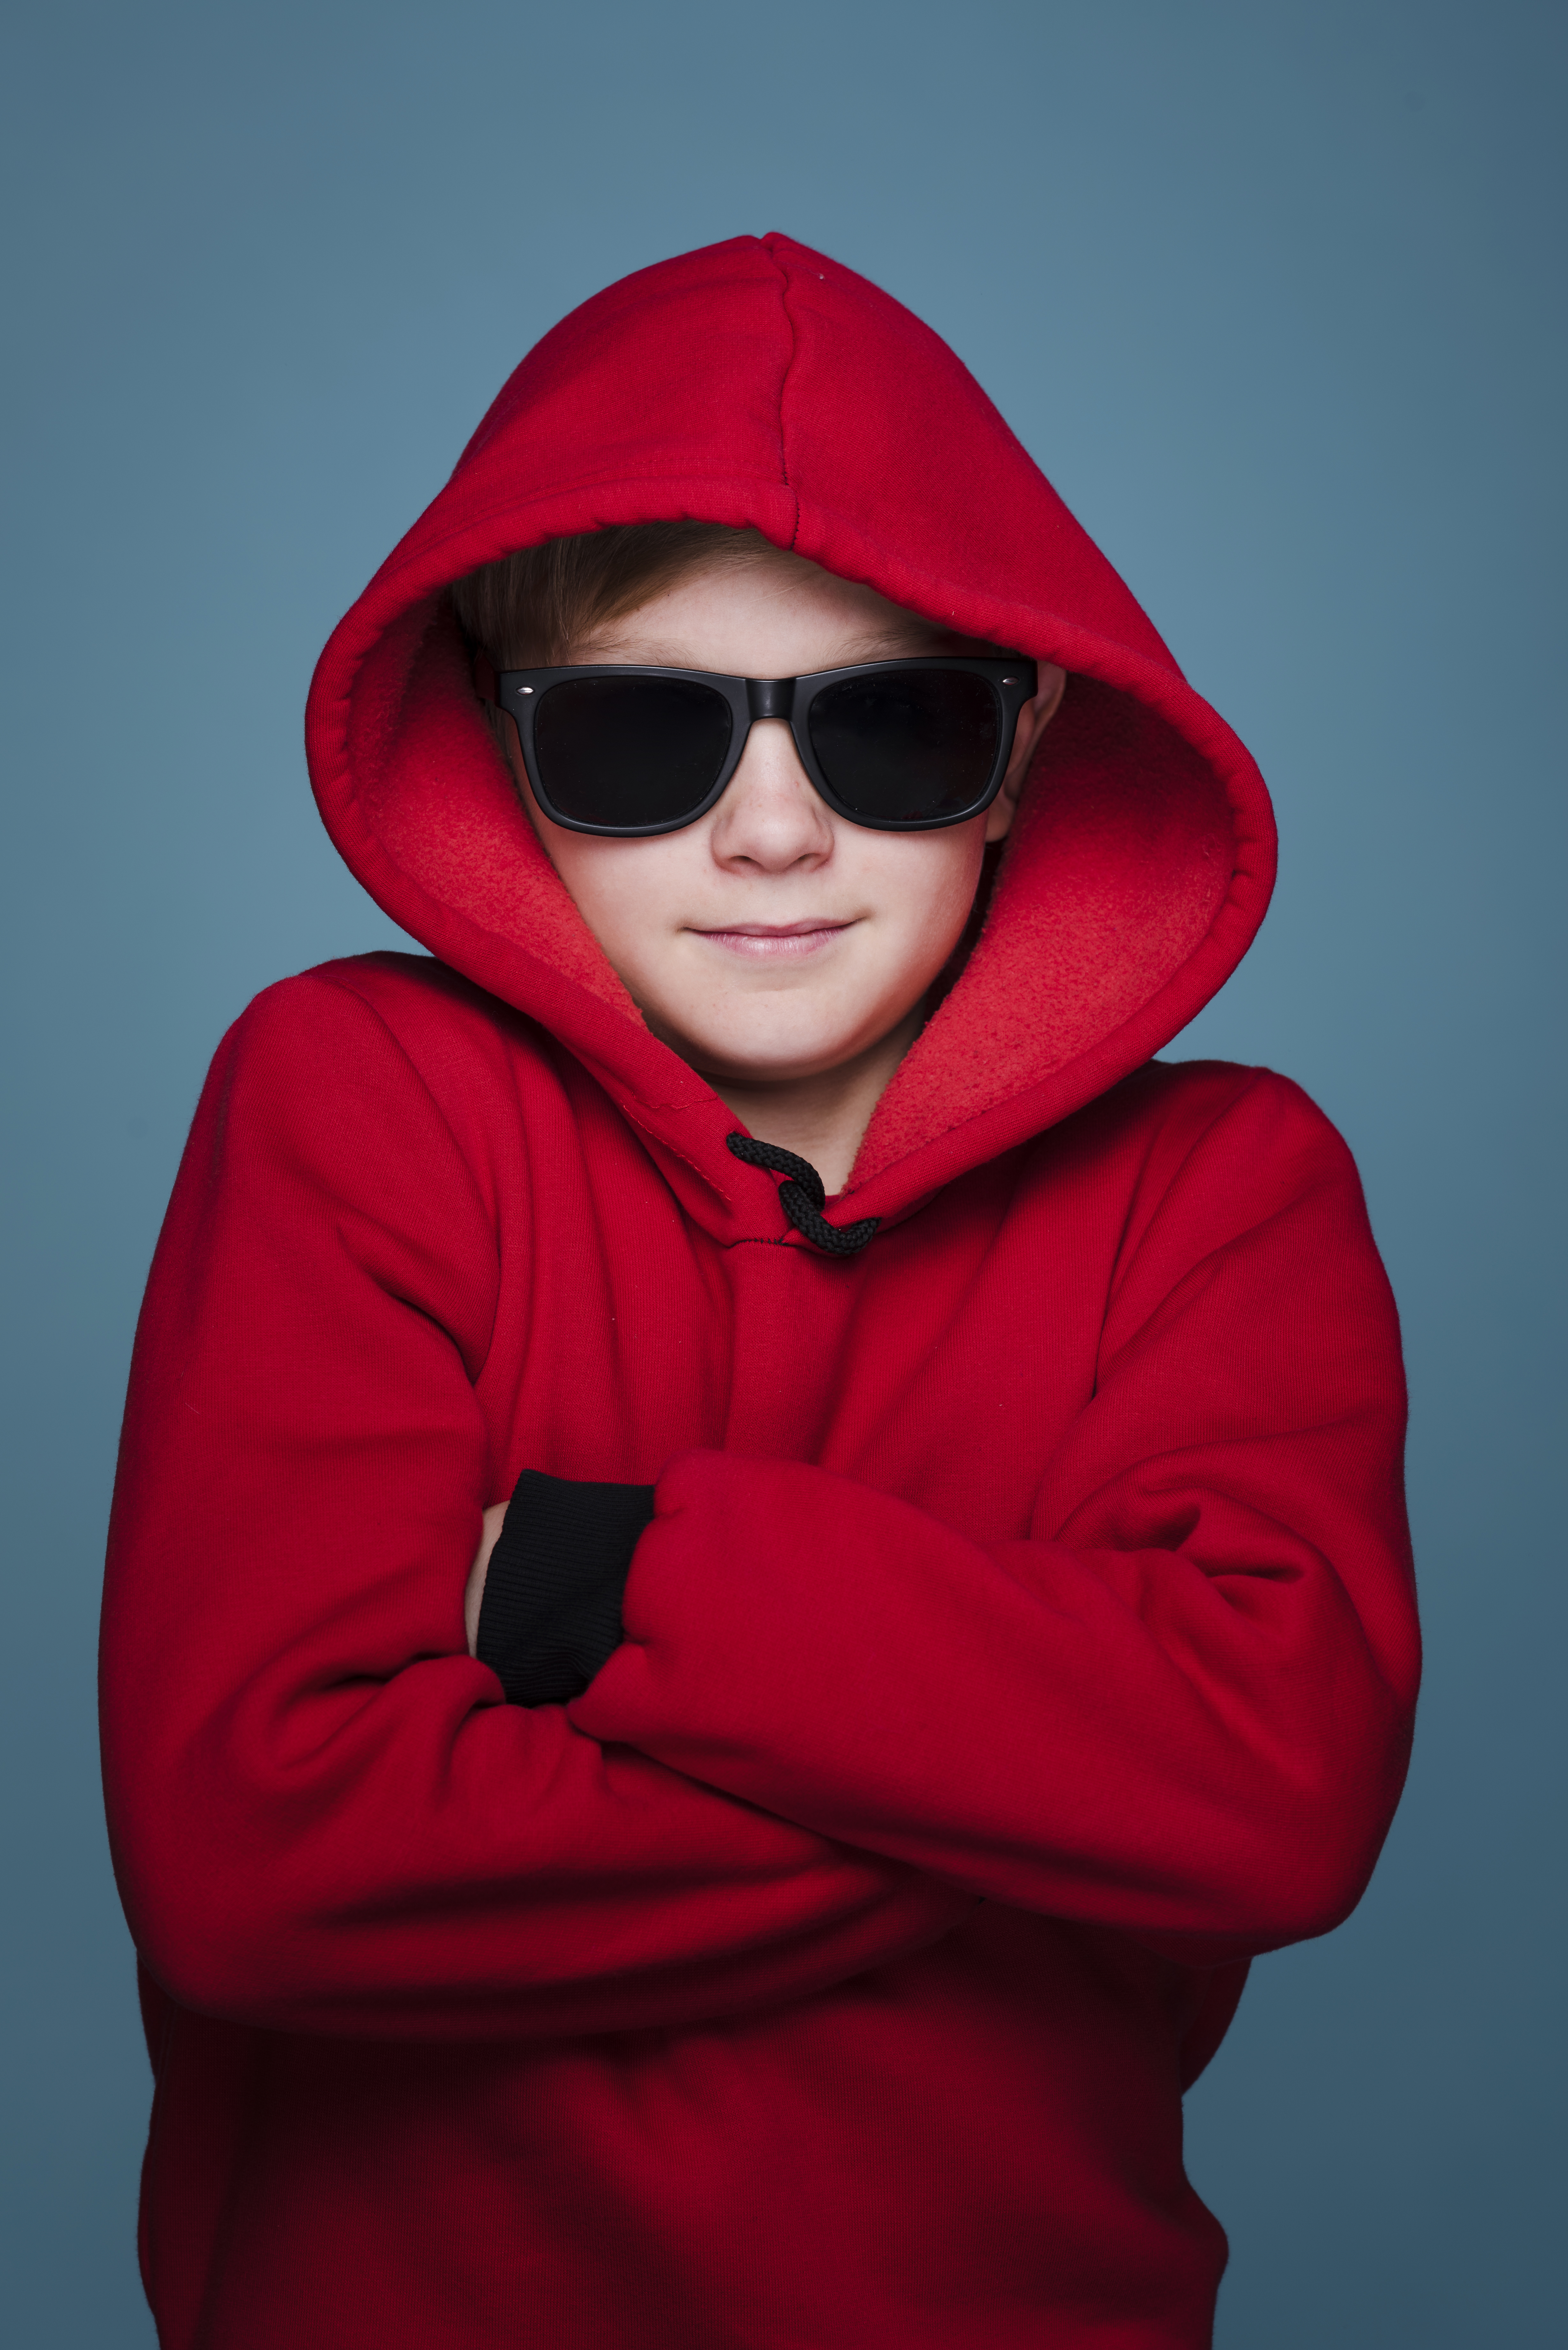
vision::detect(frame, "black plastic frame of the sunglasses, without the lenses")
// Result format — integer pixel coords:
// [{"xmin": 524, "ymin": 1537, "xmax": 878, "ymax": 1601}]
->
[{"xmin": 486, "ymin": 653, "xmax": 1039, "ymax": 841}]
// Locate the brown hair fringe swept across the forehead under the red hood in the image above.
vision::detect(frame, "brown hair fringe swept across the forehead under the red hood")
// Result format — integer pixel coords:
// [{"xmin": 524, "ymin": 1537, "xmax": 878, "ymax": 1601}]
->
[{"xmin": 451, "ymin": 522, "xmax": 795, "ymax": 670}]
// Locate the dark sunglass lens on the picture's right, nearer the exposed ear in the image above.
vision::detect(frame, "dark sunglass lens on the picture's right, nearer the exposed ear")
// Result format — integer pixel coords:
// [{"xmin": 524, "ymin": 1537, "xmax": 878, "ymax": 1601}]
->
[{"xmin": 809, "ymin": 670, "xmax": 1001, "ymax": 825}]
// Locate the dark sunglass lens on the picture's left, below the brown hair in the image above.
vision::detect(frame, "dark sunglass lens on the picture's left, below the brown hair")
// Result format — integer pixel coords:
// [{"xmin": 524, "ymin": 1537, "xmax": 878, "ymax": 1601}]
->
[{"xmin": 534, "ymin": 677, "xmax": 734, "ymax": 832}]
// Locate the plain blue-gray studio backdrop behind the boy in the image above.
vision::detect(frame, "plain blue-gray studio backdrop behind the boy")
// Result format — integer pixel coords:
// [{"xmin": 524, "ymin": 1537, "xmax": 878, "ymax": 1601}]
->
[{"xmin": 0, "ymin": 0, "xmax": 1568, "ymax": 2350}]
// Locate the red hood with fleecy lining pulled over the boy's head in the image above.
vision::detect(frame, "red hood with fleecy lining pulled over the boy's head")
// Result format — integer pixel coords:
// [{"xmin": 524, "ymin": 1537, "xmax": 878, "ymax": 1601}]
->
[{"xmin": 305, "ymin": 235, "xmax": 1274, "ymax": 1232}]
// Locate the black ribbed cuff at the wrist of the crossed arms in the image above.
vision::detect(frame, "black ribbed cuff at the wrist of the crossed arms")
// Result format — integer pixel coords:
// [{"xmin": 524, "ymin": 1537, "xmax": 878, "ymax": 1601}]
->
[{"xmin": 477, "ymin": 1469, "xmax": 653, "ymax": 1706}]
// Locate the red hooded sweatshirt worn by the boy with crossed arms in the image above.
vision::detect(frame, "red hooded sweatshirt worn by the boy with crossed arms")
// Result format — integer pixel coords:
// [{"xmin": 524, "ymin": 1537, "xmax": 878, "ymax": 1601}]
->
[{"xmin": 103, "ymin": 235, "xmax": 1418, "ymax": 2350}]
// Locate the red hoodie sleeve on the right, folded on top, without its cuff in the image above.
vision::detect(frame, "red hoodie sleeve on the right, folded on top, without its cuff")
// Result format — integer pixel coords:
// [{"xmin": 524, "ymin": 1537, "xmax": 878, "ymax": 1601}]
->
[{"xmin": 569, "ymin": 1074, "xmax": 1418, "ymax": 1962}]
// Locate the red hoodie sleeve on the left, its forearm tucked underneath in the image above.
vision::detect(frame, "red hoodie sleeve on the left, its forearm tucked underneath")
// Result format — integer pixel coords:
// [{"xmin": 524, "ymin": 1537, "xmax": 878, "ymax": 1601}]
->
[{"xmin": 101, "ymin": 982, "xmax": 969, "ymax": 2040}]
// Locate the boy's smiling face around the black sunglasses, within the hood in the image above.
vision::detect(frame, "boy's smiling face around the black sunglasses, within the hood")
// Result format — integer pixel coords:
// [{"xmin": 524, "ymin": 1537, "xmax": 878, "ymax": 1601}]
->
[{"xmin": 508, "ymin": 559, "xmax": 1063, "ymax": 1088}]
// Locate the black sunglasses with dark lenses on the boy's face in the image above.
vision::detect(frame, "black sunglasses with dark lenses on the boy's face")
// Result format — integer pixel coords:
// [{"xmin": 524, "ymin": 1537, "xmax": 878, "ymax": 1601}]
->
[{"xmin": 482, "ymin": 656, "xmax": 1039, "ymax": 839}]
